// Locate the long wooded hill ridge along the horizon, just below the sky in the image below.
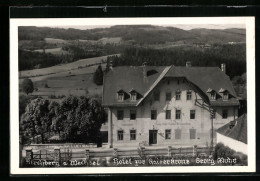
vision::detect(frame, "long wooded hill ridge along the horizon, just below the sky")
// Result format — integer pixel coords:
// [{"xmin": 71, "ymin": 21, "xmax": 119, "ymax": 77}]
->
[{"xmin": 19, "ymin": 25, "xmax": 246, "ymax": 44}]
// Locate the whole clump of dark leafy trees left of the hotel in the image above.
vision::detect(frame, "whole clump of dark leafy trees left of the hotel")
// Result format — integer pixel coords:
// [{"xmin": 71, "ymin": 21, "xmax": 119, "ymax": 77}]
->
[{"xmin": 20, "ymin": 96, "xmax": 106, "ymax": 143}]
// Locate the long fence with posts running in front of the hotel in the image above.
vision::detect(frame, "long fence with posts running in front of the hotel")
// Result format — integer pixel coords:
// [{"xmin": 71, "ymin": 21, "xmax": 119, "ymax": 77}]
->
[{"xmin": 23, "ymin": 146, "xmax": 211, "ymax": 162}]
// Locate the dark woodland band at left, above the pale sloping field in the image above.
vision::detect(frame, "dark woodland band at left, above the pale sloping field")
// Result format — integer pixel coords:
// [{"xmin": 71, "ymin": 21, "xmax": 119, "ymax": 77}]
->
[{"xmin": 18, "ymin": 43, "xmax": 125, "ymax": 71}]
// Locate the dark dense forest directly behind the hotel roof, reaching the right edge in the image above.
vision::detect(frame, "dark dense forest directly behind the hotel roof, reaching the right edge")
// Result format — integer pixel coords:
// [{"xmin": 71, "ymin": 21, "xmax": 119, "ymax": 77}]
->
[{"xmin": 108, "ymin": 44, "xmax": 246, "ymax": 78}]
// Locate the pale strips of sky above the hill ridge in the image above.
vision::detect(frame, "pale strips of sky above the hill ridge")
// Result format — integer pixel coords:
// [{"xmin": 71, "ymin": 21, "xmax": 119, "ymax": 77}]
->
[{"xmin": 47, "ymin": 24, "xmax": 245, "ymax": 30}]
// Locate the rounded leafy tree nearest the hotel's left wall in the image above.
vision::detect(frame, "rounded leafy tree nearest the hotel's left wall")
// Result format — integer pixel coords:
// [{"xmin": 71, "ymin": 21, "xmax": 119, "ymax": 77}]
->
[{"xmin": 60, "ymin": 96, "xmax": 106, "ymax": 142}]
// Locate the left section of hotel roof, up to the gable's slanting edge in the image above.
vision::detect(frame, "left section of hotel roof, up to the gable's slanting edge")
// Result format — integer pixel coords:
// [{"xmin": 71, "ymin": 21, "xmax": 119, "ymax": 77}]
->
[{"xmin": 103, "ymin": 66, "xmax": 166, "ymax": 106}]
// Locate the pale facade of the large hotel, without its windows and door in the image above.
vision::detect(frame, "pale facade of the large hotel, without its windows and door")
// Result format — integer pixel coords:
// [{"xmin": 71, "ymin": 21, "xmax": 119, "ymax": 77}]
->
[{"xmin": 109, "ymin": 79, "xmax": 238, "ymax": 147}]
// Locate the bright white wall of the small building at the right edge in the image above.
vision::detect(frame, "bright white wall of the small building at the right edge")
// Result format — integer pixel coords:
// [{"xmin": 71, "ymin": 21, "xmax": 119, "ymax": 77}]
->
[{"xmin": 217, "ymin": 133, "xmax": 247, "ymax": 155}]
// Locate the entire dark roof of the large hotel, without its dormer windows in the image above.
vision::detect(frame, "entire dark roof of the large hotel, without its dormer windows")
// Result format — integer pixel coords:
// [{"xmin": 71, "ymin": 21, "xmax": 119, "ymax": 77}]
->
[{"xmin": 103, "ymin": 66, "xmax": 239, "ymax": 106}]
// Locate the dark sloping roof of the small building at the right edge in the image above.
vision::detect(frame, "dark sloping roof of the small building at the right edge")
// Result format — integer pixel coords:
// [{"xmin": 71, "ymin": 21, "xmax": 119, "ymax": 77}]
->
[{"xmin": 217, "ymin": 114, "xmax": 247, "ymax": 144}]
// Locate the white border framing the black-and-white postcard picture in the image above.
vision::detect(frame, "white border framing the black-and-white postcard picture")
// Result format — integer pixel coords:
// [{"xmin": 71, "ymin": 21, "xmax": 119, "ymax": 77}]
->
[{"xmin": 10, "ymin": 17, "xmax": 256, "ymax": 174}]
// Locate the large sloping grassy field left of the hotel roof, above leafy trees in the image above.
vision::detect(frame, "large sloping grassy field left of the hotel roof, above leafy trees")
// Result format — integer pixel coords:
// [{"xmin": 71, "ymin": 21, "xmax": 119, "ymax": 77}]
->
[{"xmin": 19, "ymin": 56, "xmax": 117, "ymax": 99}]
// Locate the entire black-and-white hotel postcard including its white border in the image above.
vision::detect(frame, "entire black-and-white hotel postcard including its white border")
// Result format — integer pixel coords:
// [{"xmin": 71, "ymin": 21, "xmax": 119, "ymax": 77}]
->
[{"xmin": 10, "ymin": 17, "xmax": 256, "ymax": 174}]
